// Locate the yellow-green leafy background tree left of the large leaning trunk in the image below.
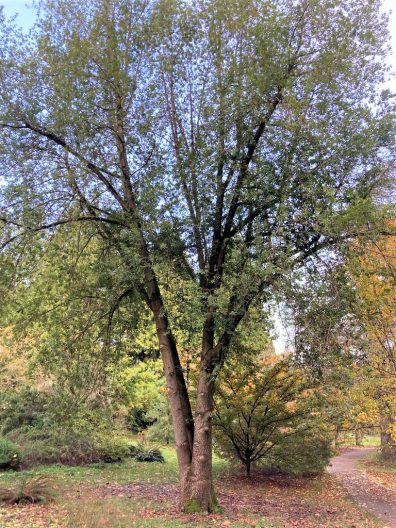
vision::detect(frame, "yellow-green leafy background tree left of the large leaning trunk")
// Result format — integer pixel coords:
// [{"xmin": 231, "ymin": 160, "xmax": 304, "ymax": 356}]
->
[{"xmin": 0, "ymin": 224, "xmax": 145, "ymax": 428}]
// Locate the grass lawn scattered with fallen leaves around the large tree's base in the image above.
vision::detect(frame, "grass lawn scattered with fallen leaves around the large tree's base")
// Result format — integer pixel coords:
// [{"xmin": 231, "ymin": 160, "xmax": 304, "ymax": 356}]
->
[{"xmin": 0, "ymin": 449, "xmax": 380, "ymax": 528}]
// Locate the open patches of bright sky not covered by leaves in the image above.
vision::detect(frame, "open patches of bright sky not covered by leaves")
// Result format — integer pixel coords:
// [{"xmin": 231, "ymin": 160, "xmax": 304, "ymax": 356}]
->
[{"xmin": 0, "ymin": 0, "xmax": 396, "ymax": 353}]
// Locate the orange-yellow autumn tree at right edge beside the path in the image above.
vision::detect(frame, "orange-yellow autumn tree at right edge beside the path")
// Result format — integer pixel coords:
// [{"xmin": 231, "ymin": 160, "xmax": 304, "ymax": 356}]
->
[{"xmin": 350, "ymin": 220, "xmax": 396, "ymax": 458}]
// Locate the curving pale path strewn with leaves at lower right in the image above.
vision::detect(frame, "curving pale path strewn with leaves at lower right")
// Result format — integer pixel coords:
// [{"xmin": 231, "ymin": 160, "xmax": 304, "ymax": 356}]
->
[{"xmin": 328, "ymin": 448, "xmax": 396, "ymax": 528}]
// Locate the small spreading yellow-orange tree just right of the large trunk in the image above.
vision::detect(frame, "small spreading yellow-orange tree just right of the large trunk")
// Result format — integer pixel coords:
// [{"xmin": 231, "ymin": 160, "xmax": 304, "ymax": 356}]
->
[{"xmin": 214, "ymin": 358, "xmax": 331, "ymax": 475}]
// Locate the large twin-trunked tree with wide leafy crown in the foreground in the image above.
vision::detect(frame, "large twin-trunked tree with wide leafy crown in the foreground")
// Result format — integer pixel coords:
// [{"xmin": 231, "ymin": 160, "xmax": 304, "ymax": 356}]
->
[{"xmin": 0, "ymin": 0, "xmax": 393, "ymax": 510}]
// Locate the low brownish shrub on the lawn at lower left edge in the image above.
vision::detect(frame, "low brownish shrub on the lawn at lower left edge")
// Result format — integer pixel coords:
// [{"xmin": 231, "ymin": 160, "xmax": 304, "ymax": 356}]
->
[{"xmin": 0, "ymin": 476, "xmax": 54, "ymax": 504}]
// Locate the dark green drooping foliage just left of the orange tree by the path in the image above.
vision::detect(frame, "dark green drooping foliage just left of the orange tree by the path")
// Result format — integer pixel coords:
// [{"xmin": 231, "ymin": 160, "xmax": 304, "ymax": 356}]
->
[{"xmin": 283, "ymin": 262, "xmax": 363, "ymax": 378}]
